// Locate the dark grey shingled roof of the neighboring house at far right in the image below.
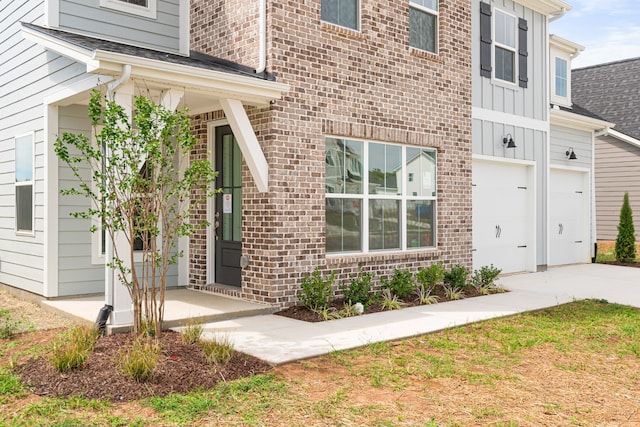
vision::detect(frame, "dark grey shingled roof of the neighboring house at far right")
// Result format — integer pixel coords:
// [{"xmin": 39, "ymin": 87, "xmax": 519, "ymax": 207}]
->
[{"xmin": 571, "ymin": 58, "xmax": 640, "ymax": 139}]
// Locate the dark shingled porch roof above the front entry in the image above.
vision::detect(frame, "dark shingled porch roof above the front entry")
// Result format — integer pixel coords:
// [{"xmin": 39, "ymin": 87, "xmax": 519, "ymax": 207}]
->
[{"xmin": 22, "ymin": 22, "xmax": 275, "ymax": 80}]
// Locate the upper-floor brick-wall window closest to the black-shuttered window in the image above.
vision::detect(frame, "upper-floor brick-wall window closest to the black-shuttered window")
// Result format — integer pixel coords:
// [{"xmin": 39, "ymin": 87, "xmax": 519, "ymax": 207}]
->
[{"xmin": 409, "ymin": 0, "xmax": 438, "ymax": 53}]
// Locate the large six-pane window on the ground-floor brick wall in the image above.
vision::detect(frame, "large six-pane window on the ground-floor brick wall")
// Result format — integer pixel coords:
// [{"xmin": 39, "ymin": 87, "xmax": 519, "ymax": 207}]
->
[{"xmin": 325, "ymin": 138, "xmax": 436, "ymax": 253}]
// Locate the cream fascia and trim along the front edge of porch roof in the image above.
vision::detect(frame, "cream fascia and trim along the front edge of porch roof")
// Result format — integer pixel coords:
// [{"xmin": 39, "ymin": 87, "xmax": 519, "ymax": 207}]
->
[{"xmin": 87, "ymin": 50, "xmax": 290, "ymax": 105}]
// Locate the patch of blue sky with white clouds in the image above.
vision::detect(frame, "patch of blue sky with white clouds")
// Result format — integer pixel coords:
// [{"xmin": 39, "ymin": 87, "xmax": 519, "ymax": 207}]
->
[{"xmin": 550, "ymin": 0, "xmax": 640, "ymax": 68}]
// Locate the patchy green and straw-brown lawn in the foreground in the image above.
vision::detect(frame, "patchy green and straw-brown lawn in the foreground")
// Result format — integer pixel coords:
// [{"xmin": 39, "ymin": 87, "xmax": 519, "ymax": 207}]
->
[{"xmin": 0, "ymin": 300, "xmax": 640, "ymax": 427}]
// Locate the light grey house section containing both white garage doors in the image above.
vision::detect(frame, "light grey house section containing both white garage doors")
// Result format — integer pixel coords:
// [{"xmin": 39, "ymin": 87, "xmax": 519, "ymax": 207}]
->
[{"xmin": 472, "ymin": 0, "xmax": 608, "ymax": 273}]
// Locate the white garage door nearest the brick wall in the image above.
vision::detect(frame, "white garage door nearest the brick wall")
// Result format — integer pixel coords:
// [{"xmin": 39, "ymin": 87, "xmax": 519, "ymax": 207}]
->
[{"xmin": 473, "ymin": 159, "xmax": 535, "ymax": 273}]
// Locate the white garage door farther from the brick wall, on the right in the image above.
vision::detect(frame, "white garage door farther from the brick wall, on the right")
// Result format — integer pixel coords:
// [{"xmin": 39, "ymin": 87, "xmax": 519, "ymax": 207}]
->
[{"xmin": 549, "ymin": 169, "xmax": 591, "ymax": 265}]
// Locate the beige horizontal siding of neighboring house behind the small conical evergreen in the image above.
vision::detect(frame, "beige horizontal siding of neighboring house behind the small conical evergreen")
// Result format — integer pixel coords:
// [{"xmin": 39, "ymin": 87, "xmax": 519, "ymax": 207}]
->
[{"xmin": 595, "ymin": 136, "xmax": 640, "ymax": 241}]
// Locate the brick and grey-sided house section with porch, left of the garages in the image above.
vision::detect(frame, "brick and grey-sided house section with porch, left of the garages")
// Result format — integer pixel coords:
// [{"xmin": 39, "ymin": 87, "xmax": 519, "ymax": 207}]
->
[{"xmin": 0, "ymin": 0, "xmax": 472, "ymax": 325}]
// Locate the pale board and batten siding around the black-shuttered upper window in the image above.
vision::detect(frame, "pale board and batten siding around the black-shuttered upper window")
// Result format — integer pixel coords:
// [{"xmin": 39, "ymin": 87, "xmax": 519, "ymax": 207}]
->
[{"xmin": 471, "ymin": 0, "xmax": 549, "ymax": 120}]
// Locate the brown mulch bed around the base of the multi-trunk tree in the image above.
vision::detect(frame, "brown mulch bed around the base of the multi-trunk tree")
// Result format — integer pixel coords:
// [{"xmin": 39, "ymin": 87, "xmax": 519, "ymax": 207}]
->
[{"xmin": 17, "ymin": 331, "xmax": 271, "ymax": 401}]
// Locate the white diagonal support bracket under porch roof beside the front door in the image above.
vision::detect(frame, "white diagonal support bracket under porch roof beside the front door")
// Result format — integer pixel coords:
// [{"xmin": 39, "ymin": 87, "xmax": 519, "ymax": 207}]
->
[{"xmin": 220, "ymin": 99, "xmax": 269, "ymax": 193}]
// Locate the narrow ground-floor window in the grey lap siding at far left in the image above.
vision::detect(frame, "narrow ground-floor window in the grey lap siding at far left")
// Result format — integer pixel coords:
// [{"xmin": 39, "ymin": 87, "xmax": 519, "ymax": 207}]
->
[{"xmin": 15, "ymin": 133, "xmax": 34, "ymax": 235}]
